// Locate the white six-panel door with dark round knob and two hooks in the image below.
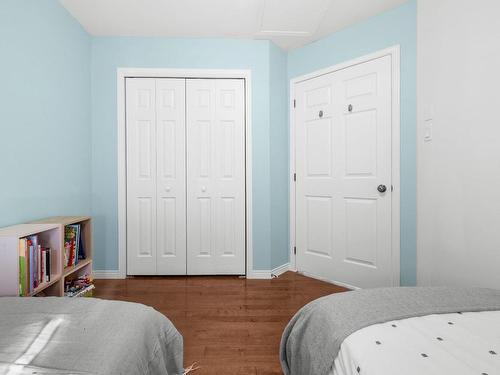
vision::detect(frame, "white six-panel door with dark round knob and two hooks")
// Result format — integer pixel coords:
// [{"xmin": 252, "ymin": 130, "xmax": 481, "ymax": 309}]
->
[{"xmin": 295, "ymin": 56, "xmax": 394, "ymax": 288}]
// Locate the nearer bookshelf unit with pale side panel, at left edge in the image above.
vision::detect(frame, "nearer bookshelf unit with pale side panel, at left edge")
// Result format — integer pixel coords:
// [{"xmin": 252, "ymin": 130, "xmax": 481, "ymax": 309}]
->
[{"xmin": 0, "ymin": 223, "xmax": 64, "ymax": 296}]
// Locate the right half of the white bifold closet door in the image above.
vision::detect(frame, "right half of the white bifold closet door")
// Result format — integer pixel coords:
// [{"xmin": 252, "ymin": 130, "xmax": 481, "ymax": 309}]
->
[{"xmin": 186, "ymin": 79, "xmax": 245, "ymax": 275}]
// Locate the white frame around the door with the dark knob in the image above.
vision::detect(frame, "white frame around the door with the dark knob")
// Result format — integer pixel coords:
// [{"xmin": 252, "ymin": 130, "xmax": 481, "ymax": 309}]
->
[{"xmin": 290, "ymin": 45, "xmax": 401, "ymax": 286}]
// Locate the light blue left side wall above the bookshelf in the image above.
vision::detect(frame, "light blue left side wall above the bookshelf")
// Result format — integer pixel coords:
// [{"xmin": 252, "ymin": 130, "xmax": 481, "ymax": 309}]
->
[{"xmin": 0, "ymin": 0, "xmax": 90, "ymax": 226}]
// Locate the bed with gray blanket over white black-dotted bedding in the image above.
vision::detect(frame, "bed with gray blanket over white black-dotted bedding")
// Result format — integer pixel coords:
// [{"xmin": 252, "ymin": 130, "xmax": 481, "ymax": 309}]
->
[{"xmin": 280, "ymin": 288, "xmax": 500, "ymax": 375}]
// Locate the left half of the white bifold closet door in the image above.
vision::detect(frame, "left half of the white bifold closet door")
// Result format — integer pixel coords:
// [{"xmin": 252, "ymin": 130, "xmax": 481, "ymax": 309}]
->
[{"xmin": 126, "ymin": 78, "xmax": 186, "ymax": 275}]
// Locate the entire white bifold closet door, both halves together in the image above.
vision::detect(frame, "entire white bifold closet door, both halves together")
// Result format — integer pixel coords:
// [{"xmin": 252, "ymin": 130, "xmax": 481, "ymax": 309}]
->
[{"xmin": 126, "ymin": 78, "xmax": 245, "ymax": 275}]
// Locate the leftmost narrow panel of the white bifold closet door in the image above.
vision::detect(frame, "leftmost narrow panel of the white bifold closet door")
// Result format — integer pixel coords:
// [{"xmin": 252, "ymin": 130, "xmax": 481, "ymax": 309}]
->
[{"xmin": 126, "ymin": 78, "xmax": 156, "ymax": 275}]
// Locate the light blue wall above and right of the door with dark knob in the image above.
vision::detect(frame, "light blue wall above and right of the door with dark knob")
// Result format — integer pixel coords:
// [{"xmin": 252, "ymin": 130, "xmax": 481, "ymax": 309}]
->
[{"xmin": 288, "ymin": 0, "xmax": 416, "ymax": 285}]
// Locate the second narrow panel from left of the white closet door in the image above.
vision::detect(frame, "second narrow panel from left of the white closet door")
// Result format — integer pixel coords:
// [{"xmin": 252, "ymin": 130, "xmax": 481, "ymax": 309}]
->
[{"xmin": 155, "ymin": 78, "xmax": 186, "ymax": 275}]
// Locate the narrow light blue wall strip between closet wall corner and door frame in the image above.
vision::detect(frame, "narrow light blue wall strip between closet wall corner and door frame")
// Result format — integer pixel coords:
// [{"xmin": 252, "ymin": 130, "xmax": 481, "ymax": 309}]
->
[{"xmin": 269, "ymin": 43, "xmax": 290, "ymax": 269}]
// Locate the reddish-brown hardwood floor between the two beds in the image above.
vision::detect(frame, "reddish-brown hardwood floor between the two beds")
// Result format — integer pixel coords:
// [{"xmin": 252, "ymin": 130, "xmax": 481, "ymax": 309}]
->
[{"xmin": 94, "ymin": 272, "xmax": 346, "ymax": 375}]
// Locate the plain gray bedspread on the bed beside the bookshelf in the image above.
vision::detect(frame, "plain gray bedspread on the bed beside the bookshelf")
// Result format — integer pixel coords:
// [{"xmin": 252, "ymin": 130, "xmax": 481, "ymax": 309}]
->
[{"xmin": 0, "ymin": 297, "xmax": 184, "ymax": 375}]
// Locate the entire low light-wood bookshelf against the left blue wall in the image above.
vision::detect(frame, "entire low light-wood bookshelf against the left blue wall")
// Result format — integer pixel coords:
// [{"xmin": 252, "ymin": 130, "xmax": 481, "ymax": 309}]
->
[{"xmin": 0, "ymin": 216, "xmax": 92, "ymax": 296}]
